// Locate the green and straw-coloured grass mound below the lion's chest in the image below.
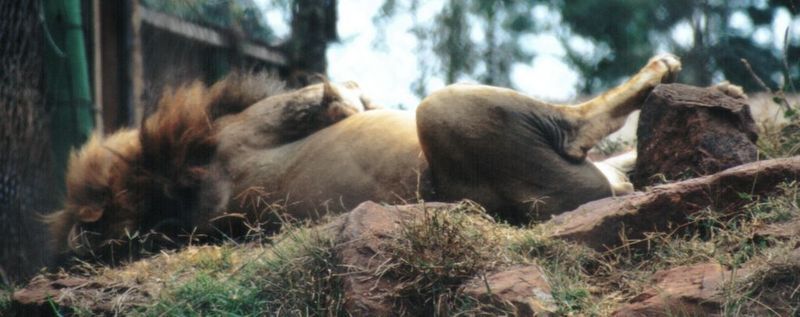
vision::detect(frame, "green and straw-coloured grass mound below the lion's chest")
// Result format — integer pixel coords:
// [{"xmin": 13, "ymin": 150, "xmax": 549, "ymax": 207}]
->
[{"xmin": 138, "ymin": 223, "xmax": 344, "ymax": 316}]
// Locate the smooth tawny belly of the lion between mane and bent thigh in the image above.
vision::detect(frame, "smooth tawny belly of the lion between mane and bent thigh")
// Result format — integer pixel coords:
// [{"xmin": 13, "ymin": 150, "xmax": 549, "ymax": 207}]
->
[{"xmin": 235, "ymin": 110, "xmax": 430, "ymax": 218}]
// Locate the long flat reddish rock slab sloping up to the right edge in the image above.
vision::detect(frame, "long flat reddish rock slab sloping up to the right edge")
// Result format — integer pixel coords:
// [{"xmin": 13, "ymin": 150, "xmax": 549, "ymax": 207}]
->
[{"xmin": 548, "ymin": 157, "xmax": 800, "ymax": 251}]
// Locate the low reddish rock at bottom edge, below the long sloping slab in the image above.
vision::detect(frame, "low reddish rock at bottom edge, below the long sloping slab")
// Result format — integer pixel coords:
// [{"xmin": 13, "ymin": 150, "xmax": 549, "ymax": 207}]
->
[{"xmin": 613, "ymin": 263, "xmax": 734, "ymax": 317}]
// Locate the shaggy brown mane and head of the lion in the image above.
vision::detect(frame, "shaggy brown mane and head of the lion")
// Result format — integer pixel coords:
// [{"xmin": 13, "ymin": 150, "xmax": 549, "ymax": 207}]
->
[{"xmin": 44, "ymin": 74, "xmax": 284, "ymax": 254}]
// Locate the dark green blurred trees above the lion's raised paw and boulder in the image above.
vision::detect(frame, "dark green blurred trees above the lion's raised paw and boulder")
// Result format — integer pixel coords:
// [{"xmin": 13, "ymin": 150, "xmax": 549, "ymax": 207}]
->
[{"xmin": 548, "ymin": 0, "xmax": 797, "ymax": 92}]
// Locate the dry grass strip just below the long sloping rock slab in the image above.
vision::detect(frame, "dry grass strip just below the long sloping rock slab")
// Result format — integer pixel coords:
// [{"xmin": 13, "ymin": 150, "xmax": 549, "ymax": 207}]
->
[{"xmin": 595, "ymin": 183, "xmax": 800, "ymax": 316}]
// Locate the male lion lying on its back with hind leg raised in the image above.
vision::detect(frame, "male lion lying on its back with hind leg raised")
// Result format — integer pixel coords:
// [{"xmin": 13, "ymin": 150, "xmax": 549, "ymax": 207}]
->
[{"xmin": 45, "ymin": 55, "xmax": 681, "ymax": 254}]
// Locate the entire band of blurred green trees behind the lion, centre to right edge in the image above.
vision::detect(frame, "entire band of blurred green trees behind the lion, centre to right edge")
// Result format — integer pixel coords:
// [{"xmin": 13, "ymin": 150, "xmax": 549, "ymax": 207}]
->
[{"xmin": 376, "ymin": 0, "xmax": 800, "ymax": 95}]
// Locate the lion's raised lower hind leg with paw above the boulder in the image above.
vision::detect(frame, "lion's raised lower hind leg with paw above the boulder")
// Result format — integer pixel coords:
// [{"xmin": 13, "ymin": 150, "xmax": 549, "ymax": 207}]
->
[{"xmin": 561, "ymin": 54, "xmax": 681, "ymax": 159}]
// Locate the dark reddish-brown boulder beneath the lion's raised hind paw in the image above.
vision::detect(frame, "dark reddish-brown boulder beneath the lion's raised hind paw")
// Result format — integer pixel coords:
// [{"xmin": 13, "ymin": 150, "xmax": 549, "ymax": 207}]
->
[{"xmin": 631, "ymin": 84, "xmax": 757, "ymax": 188}]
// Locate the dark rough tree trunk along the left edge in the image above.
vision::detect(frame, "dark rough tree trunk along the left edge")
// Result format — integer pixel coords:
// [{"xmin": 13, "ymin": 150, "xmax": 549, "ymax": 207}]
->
[{"xmin": 0, "ymin": 0, "xmax": 57, "ymax": 284}]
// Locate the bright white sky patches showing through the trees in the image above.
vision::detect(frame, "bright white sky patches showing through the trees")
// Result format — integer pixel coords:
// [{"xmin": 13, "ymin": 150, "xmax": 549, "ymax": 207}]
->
[{"xmin": 255, "ymin": 0, "xmax": 800, "ymax": 109}]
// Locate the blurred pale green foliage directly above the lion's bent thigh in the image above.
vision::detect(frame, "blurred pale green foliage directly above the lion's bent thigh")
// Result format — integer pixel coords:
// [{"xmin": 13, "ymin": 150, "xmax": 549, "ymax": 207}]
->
[{"xmin": 374, "ymin": 0, "xmax": 536, "ymax": 97}]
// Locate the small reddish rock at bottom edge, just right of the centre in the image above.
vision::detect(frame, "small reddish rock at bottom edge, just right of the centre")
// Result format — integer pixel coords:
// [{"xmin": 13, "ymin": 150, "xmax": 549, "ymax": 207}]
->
[{"xmin": 462, "ymin": 265, "xmax": 557, "ymax": 316}]
